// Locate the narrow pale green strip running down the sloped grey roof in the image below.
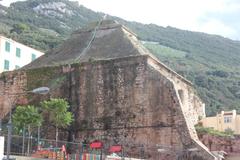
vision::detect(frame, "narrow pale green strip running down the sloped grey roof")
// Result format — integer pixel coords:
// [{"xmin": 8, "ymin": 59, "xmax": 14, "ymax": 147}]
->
[{"xmin": 75, "ymin": 14, "xmax": 107, "ymax": 62}]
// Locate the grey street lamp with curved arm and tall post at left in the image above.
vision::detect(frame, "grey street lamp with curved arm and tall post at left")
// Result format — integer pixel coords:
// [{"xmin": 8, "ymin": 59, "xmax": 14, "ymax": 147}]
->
[{"xmin": 0, "ymin": 87, "xmax": 50, "ymax": 160}]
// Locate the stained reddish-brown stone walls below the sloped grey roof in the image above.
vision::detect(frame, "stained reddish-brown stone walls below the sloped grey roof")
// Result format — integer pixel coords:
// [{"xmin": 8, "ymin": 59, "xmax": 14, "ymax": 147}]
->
[{"xmin": 0, "ymin": 56, "xmax": 213, "ymax": 160}]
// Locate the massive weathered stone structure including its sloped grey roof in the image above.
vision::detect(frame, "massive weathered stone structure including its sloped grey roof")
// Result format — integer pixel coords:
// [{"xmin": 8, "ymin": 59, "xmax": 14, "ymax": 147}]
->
[{"xmin": 0, "ymin": 21, "xmax": 215, "ymax": 160}]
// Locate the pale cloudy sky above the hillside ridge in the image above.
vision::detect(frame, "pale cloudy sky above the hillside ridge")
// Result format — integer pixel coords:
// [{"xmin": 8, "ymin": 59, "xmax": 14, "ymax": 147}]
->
[{"xmin": 1, "ymin": 0, "xmax": 240, "ymax": 40}]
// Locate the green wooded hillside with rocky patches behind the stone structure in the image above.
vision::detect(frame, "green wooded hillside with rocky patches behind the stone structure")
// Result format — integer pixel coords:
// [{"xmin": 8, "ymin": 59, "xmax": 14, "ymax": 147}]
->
[{"xmin": 0, "ymin": 0, "xmax": 240, "ymax": 115}]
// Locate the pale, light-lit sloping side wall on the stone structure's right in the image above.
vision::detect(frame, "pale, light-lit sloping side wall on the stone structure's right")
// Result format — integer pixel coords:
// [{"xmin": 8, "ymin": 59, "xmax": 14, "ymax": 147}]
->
[{"xmin": 148, "ymin": 58, "xmax": 211, "ymax": 159}]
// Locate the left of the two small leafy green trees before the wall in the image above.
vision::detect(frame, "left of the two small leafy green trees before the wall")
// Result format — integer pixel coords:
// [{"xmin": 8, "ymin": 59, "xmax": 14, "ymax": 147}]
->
[{"xmin": 13, "ymin": 105, "xmax": 43, "ymax": 155}]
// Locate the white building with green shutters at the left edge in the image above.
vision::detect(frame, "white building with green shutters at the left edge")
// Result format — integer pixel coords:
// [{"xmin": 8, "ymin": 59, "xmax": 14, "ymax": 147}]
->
[{"xmin": 0, "ymin": 35, "xmax": 44, "ymax": 73}]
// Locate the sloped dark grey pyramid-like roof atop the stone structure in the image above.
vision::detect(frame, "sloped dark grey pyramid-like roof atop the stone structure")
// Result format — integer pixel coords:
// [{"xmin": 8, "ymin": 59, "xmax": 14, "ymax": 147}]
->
[{"xmin": 24, "ymin": 20, "xmax": 154, "ymax": 69}]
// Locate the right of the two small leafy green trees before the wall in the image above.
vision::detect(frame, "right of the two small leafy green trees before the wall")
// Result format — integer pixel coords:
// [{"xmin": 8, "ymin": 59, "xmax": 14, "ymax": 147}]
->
[{"xmin": 41, "ymin": 99, "xmax": 73, "ymax": 147}]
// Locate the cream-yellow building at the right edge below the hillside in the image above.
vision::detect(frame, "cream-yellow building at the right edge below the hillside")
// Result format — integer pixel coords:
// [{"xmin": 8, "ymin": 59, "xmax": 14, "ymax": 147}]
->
[{"xmin": 200, "ymin": 110, "xmax": 240, "ymax": 134}]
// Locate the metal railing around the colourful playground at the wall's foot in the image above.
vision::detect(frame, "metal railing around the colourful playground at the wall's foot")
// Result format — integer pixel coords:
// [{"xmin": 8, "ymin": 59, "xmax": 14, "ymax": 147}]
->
[{"xmin": 3, "ymin": 134, "xmax": 148, "ymax": 160}]
